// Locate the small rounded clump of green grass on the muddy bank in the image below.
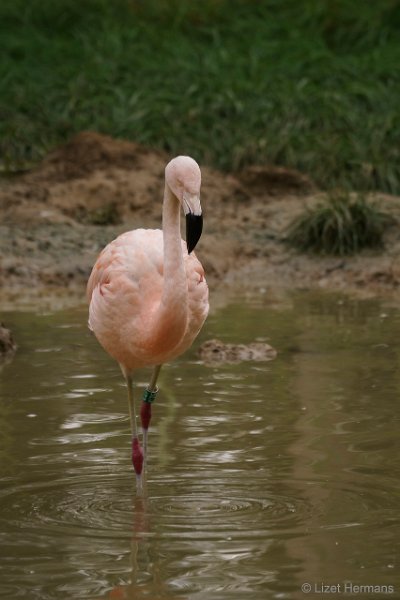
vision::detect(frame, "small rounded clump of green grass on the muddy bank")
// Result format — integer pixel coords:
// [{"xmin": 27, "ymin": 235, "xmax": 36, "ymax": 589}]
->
[{"xmin": 286, "ymin": 192, "xmax": 391, "ymax": 256}]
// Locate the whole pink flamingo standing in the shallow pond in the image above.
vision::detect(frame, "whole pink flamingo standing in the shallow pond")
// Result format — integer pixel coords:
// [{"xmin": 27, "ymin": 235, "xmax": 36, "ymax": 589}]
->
[{"xmin": 87, "ymin": 156, "xmax": 209, "ymax": 489}]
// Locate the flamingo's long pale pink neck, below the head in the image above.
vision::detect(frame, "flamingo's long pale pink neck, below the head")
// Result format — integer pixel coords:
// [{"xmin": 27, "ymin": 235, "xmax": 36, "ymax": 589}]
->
[{"xmin": 146, "ymin": 184, "xmax": 188, "ymax": 348}]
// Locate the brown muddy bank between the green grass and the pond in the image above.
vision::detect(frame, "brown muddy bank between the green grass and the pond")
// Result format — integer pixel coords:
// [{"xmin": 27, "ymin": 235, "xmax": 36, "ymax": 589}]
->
[{"xmin": 0, "ymin": 132, "xmax": 400, "ymax": 309}]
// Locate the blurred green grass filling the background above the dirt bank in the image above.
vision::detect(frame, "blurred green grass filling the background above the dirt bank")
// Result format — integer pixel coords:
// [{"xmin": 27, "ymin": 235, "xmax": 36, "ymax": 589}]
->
[{"xmin": 0, "ymin": 0, "xmax": 400, "ymax": 193}]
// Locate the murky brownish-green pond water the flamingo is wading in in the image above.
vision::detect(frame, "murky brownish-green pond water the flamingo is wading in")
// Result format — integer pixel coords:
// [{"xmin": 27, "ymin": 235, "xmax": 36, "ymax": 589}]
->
[{"xmin": 0, "ymin": 293, "xmax": 400, "ymax": 600}]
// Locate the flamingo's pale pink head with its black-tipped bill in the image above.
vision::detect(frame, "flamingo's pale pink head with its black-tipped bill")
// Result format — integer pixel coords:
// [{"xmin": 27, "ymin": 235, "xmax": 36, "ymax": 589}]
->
[{"xmin": 165, "ymin": 156, "xmax": 203, "ymax": 254}]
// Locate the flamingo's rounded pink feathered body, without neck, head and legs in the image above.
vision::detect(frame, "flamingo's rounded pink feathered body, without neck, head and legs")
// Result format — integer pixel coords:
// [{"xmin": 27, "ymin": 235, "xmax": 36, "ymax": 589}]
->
[{"xmin": 87, "ymin": 229, "xmax": 208, "ymax": 372}]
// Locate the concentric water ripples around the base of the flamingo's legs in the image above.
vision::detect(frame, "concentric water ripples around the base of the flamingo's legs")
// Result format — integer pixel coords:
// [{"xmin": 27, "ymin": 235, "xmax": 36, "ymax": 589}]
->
[{"xmin": 0, "ymin": 474, "xmax": 311, "ymax": 540}]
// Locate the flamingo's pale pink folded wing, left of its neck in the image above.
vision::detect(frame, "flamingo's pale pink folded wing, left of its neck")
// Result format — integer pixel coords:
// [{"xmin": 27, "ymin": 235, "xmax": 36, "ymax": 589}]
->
[{"xmin": 87, "ymin": 229, "xmax": 163, "ymax": 367}]
